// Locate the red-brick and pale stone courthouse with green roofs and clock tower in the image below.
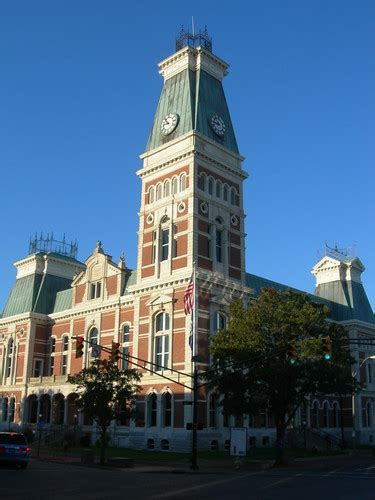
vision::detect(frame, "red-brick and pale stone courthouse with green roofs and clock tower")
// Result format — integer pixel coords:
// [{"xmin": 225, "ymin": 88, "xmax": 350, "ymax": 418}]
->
[{"xmin": 0, "ymin": 32, "xmax": 375, "ymax": 450}]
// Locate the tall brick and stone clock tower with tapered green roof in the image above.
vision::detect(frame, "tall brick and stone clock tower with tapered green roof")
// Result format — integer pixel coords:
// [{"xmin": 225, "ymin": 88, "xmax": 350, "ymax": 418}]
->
[{"xmin": 137, "ymin": 30, "xmax": 247, "ymax": 287}]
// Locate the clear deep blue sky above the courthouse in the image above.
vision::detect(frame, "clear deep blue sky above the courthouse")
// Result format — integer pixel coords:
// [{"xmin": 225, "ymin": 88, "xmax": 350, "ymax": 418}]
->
[{"xmin": 0, "ymin": 0, "xmax": 375, "ymax": 310}]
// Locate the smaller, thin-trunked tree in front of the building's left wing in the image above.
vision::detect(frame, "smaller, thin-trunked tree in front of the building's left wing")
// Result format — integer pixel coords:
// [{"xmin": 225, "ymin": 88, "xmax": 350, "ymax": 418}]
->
[{"xmin": 68, "ymin": 359, "xmax": 140, "ymax": 464}]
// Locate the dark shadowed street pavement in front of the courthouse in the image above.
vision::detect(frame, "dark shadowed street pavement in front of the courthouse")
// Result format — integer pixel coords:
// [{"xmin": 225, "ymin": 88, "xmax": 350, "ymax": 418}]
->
[{"xmin": 0, "ymin": 457, "xmax": 375, "ymax": 500}]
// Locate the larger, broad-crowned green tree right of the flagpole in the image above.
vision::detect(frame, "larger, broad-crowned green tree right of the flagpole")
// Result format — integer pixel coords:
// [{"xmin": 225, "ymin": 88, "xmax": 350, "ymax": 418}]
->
[{"xmin": 210, "ymin": 289, "xmax": 355, "ymax": 464}]
